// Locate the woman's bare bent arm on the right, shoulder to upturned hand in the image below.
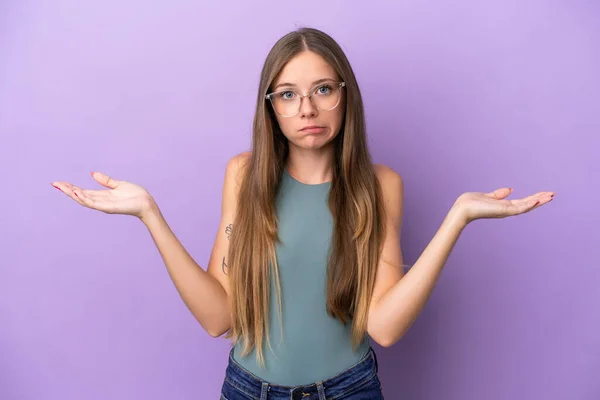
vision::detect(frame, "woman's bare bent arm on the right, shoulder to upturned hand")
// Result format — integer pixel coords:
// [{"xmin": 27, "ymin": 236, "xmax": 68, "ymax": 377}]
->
[{"xmin": 368, "ymin": 170, "xmax": 554, "ymax": 347}]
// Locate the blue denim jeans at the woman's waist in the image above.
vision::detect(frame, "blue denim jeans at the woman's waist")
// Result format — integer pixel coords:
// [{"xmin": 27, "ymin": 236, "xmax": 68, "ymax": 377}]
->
[{"xmin": 221, "ymin": 348, "xmax": 383, "ymax": 400}]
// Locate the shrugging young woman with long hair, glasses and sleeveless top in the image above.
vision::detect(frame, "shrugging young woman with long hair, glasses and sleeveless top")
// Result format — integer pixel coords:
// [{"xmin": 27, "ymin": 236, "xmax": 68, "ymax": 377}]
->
[{"xmin": 53, "ymin": 28, "xmax": 554, "ymax": 400}]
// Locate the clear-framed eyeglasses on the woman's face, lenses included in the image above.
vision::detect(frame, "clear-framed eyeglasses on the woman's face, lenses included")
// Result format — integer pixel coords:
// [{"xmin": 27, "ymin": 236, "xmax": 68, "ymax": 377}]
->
[{"xmin": 265, "ymin": 81, "xmax": 346, "ymax": 117}]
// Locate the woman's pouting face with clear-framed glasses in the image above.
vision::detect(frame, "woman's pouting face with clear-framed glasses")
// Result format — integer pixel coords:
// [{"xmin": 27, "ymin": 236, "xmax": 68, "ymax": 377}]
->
[{"xmin": 272, "ymin": 51, "xmax": 345, "ymax": 149}]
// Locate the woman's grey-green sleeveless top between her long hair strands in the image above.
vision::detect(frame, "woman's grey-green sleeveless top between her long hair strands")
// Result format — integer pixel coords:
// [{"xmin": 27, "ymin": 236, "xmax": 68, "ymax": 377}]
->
[{"xmin": 233, "ymin": 169, "xmax": 370, "ymax": 386}]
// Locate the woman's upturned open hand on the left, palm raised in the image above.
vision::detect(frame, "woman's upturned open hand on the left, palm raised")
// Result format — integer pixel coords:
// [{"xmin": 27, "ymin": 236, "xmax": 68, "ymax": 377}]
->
[{"xmin": 52, "ymin": 172, "xmax": 155, "ymax": 219}]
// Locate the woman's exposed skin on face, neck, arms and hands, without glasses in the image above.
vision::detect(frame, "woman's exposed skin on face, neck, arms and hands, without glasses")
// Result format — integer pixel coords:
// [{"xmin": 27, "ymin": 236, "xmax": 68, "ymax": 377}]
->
[{"xmin": 52, "ymin": 51, "xmax": 555, "ymax": 346}]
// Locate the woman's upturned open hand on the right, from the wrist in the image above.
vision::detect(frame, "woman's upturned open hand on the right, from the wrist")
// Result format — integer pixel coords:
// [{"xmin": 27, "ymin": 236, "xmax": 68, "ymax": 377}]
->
[{"xmin": 454, "ymin": 188, "xmax": 555, "ymax": 224}]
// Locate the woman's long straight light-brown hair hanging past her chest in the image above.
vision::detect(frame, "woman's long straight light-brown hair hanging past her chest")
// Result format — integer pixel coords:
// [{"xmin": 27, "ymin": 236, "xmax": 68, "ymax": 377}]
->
[{"xmin": 225, "ymin": 28, "xmax": 385, "ymax": 365}]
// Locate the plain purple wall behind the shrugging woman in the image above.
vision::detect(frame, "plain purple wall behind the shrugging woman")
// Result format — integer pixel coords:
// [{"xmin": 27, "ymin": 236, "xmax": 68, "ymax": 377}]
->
[{"xmin": 0, "ymin": 0, "xmax": 600, "ymax": 400}]
